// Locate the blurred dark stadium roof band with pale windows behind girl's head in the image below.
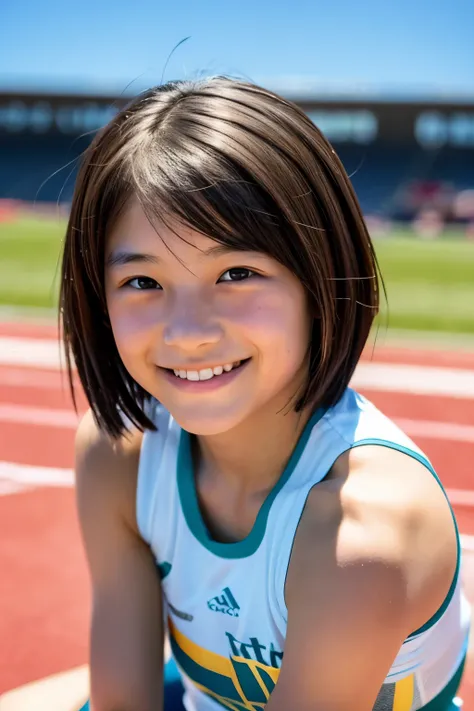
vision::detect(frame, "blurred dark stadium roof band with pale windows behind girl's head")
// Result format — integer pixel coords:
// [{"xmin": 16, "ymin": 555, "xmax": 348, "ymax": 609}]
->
[{"xmin": 0, "ymin": 76, "xmax": 474, "ymax": 151}]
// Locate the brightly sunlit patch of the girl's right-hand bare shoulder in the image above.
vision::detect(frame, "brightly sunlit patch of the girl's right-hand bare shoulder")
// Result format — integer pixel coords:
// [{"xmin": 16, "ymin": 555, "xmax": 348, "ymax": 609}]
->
[{"xmin": 342, "ymin": 446, "xmax": 458, "ymax": 603}]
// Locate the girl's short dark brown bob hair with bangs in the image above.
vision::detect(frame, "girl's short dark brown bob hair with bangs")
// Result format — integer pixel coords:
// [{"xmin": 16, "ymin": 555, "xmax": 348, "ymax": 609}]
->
[{"xmin": 60, "ymin": 77, "xmax": 379, "ymax": 437}]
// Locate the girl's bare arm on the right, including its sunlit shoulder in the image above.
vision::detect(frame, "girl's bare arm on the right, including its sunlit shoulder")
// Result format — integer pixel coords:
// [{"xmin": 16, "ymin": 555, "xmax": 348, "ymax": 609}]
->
[{"xmin": 268, "ymin": 448, "xmax": 456, "ymax": 711}]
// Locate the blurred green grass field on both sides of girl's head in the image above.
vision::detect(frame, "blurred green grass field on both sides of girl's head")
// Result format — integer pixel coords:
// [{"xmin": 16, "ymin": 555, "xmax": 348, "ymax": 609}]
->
[{"xmin": 0, "ymin": 218, "xmax": 474, "ymax": 334}]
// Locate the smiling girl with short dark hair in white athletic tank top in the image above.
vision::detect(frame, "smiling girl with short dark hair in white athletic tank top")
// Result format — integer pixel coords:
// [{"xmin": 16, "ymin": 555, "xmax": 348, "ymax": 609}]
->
[{"xmin": 61, "ymin": 78, "xmax": 469, "ymax": 711}]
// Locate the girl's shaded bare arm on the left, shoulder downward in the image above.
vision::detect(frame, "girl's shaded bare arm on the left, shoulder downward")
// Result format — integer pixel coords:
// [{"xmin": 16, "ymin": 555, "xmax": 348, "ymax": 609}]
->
[{"xmin": 76, "ymin": 413, "xmax": 163, "ymax": 711}]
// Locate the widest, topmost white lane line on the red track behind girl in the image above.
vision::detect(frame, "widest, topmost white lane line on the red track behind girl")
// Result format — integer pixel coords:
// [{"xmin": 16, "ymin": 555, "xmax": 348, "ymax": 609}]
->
[{"xmin": 0, "ymin": 336, "xmax": 474, "ymax": 399}]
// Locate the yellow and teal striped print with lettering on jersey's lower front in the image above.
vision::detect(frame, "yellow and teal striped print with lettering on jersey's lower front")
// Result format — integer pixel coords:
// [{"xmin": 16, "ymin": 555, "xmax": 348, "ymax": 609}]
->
[{"xmin": 168, "ymin": 619, "xmax": 283, "ymax": 711}]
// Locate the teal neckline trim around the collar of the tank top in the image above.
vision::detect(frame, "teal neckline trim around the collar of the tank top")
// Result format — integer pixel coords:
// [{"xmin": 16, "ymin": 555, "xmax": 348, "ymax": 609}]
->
[{"xmin": 177, "ymin": 408, "xmax": 326, "ymax": 558}]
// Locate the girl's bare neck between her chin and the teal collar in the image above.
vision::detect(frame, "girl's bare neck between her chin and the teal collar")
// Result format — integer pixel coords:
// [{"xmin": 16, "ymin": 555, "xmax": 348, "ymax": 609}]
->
[{"xmin": 196, "ymin": 404, "xmax": 311, "ymax": 494}]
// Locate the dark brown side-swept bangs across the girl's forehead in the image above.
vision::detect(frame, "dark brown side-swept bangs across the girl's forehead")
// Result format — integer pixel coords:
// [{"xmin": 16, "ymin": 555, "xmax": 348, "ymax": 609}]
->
[{"xmin": 127, "ymin": 125, "xmax": 297, "ymax": 269}]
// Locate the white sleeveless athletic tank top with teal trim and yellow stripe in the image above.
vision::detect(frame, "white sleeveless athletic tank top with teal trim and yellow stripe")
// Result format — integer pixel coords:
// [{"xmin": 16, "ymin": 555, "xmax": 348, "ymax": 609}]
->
[{"xmin": 137, "ymin": 389, "xmax": 470, "ymax": 711}]
